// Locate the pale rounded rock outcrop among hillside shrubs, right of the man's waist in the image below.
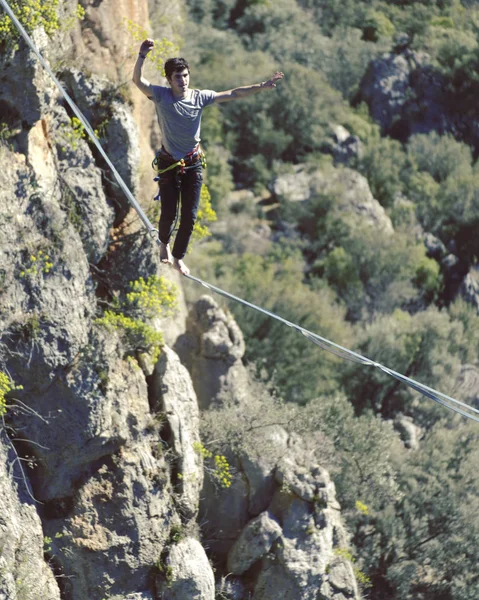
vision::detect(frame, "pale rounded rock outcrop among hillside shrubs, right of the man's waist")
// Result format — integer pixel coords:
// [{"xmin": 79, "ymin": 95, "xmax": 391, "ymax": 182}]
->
[{"xmin": 274, "ymin": 165, "xmax": 393, "ymax": 233}]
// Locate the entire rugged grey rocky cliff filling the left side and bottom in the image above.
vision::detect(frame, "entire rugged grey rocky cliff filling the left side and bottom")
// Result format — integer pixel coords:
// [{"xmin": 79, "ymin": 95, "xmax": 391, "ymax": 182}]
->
[{"xmin": 0, "ymin": 2, "xmax": 358, "ymax": 600}]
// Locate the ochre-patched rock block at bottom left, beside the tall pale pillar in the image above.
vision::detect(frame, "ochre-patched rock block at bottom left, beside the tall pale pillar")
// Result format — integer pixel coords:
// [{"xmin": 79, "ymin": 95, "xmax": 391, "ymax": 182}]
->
[{"xmin": 45, "ymin": 436, "xmax": 174, "ymax": 600}]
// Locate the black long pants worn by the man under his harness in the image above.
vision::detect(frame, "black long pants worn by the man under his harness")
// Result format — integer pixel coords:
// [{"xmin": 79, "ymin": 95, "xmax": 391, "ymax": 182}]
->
[{"xmin": 158, "ymin": 160, "xmax": 203, "ymax": 259}]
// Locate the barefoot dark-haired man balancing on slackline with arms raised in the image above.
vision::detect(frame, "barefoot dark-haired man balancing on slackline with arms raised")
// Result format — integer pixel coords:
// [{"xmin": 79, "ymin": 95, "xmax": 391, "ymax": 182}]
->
[{"xmin": 133, "ymin": 39, "xmax": 283, "ymax": 275}]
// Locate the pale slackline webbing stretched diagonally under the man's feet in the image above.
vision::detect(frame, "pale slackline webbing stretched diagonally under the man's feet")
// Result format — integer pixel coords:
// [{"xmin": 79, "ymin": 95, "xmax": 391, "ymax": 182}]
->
[{"xmin": 0, "ymin": 0, "xmax": 479, "ymax": 422}]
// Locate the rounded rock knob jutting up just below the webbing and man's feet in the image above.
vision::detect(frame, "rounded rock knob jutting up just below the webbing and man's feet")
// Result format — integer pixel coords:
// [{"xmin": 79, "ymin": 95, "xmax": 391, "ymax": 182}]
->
[{"xmin": 175, "ymin": 296, "xmax": 248, "ymax": 409}]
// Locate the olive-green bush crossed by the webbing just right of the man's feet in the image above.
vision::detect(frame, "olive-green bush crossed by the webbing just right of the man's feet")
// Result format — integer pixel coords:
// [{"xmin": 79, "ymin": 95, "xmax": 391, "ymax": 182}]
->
[{"xmin": 216, "ymin": 248, "xmax": 351, "ymax": 402}]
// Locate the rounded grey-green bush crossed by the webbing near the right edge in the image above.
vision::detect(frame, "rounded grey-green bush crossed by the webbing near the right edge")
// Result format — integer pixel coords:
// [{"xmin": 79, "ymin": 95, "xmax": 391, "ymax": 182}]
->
[{"xmin": 344, "ymin": 308, "xmax": 475, "ymax": 427}]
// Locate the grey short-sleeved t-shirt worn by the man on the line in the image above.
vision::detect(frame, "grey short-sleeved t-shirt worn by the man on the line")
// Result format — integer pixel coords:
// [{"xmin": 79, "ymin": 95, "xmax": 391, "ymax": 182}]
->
[{"xmin": 151, "ymin": 85, "xmax": 216, "ymax": 160}]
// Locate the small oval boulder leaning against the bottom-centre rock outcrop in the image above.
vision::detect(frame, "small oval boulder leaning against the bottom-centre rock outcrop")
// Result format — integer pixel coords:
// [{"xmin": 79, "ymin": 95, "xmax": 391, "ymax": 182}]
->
[{"xmin": 228, "ymin": 512, "xmax": 282, "ymax": 575}]
